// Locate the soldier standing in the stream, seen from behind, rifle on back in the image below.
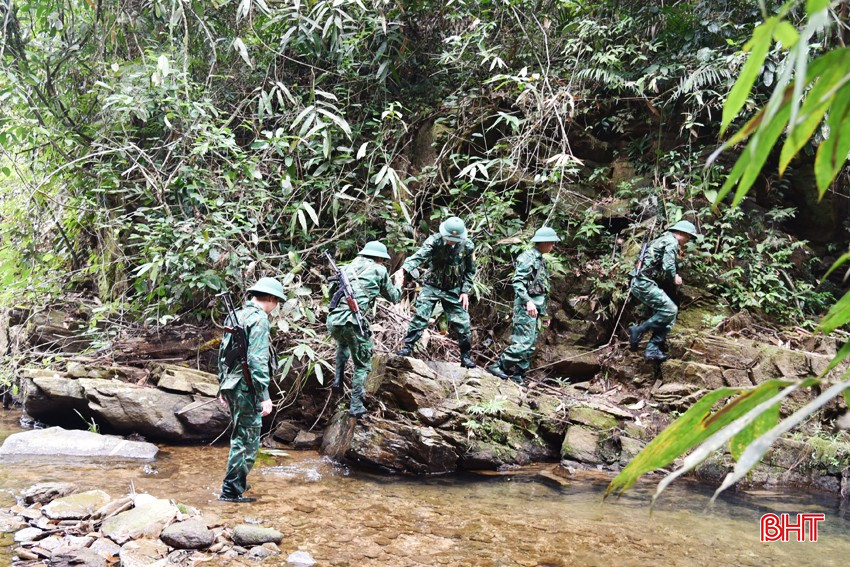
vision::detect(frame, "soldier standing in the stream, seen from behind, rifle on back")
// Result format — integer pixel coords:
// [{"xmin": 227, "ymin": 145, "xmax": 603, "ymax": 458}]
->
[{"xmin": 218, "ymin": 278, "xmax": 286, "ymax": 502}]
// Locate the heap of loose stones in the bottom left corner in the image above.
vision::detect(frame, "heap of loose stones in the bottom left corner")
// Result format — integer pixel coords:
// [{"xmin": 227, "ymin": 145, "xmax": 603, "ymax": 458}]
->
[{"xmin": 0, "ymin": 482, "xmax": 315, "ymax": 567}]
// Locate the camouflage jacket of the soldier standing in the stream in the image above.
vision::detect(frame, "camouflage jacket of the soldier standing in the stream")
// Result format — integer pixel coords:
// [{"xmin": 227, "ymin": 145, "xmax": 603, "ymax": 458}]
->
[{"xmin": 218, "ymin": 301, "xmax": 276, "ymax": 400}]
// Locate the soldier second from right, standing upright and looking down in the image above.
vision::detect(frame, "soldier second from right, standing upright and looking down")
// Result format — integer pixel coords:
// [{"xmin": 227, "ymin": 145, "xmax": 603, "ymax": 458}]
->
[{"xmin": 487, "ymin": 226, "xmax": 561, "ymax": 385}]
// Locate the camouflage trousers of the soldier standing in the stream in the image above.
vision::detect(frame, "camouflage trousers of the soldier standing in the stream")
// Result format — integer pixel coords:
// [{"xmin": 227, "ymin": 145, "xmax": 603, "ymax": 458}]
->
[{"xmin": 221, "ymin": 382, "xmax": 263, "ymax": 497}]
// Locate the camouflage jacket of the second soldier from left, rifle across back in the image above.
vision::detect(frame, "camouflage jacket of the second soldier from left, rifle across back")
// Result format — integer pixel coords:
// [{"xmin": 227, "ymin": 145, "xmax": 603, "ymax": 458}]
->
[{"xmin": 328, "ymin": 256, "xmax": 401, "ymax": 327}]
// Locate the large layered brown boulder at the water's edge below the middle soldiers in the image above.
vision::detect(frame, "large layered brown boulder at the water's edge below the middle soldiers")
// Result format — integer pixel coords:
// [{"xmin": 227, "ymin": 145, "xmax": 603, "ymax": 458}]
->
[{"xmin": 322, "ymin": 357, "xmax": 608, "ymax": 474}]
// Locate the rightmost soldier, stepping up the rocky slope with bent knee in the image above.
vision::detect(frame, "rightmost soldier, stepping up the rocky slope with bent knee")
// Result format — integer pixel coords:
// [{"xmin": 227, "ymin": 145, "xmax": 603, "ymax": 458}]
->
[{"xmin": 629, "ymin": 220, "xmax": 697, "ymax": 362}]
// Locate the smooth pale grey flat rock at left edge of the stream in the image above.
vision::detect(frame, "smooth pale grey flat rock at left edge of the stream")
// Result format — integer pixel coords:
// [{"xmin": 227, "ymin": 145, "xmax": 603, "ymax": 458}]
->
[{"xmin": 0, "ymin": 427, "xmax": 159, "ymax": 460}]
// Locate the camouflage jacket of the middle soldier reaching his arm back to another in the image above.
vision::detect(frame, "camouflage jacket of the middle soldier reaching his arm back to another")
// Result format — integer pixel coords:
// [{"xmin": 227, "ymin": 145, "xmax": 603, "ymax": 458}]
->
[{"xmin": 402, "ymin": 233, "xmax": 475, "ymax": 293}]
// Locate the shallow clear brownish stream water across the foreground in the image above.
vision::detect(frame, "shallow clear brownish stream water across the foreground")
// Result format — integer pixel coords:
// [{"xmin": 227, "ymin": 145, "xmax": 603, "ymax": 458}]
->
[{"xmin": 0, "ymin": 413, "xmax": 850, "ymax": 567}]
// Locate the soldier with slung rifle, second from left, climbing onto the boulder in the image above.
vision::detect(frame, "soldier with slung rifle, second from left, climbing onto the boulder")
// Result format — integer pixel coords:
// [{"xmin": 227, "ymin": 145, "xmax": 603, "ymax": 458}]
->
[{"xmin": 327, "ymin": 240, "xmax": 401, "ymax": 417}]
